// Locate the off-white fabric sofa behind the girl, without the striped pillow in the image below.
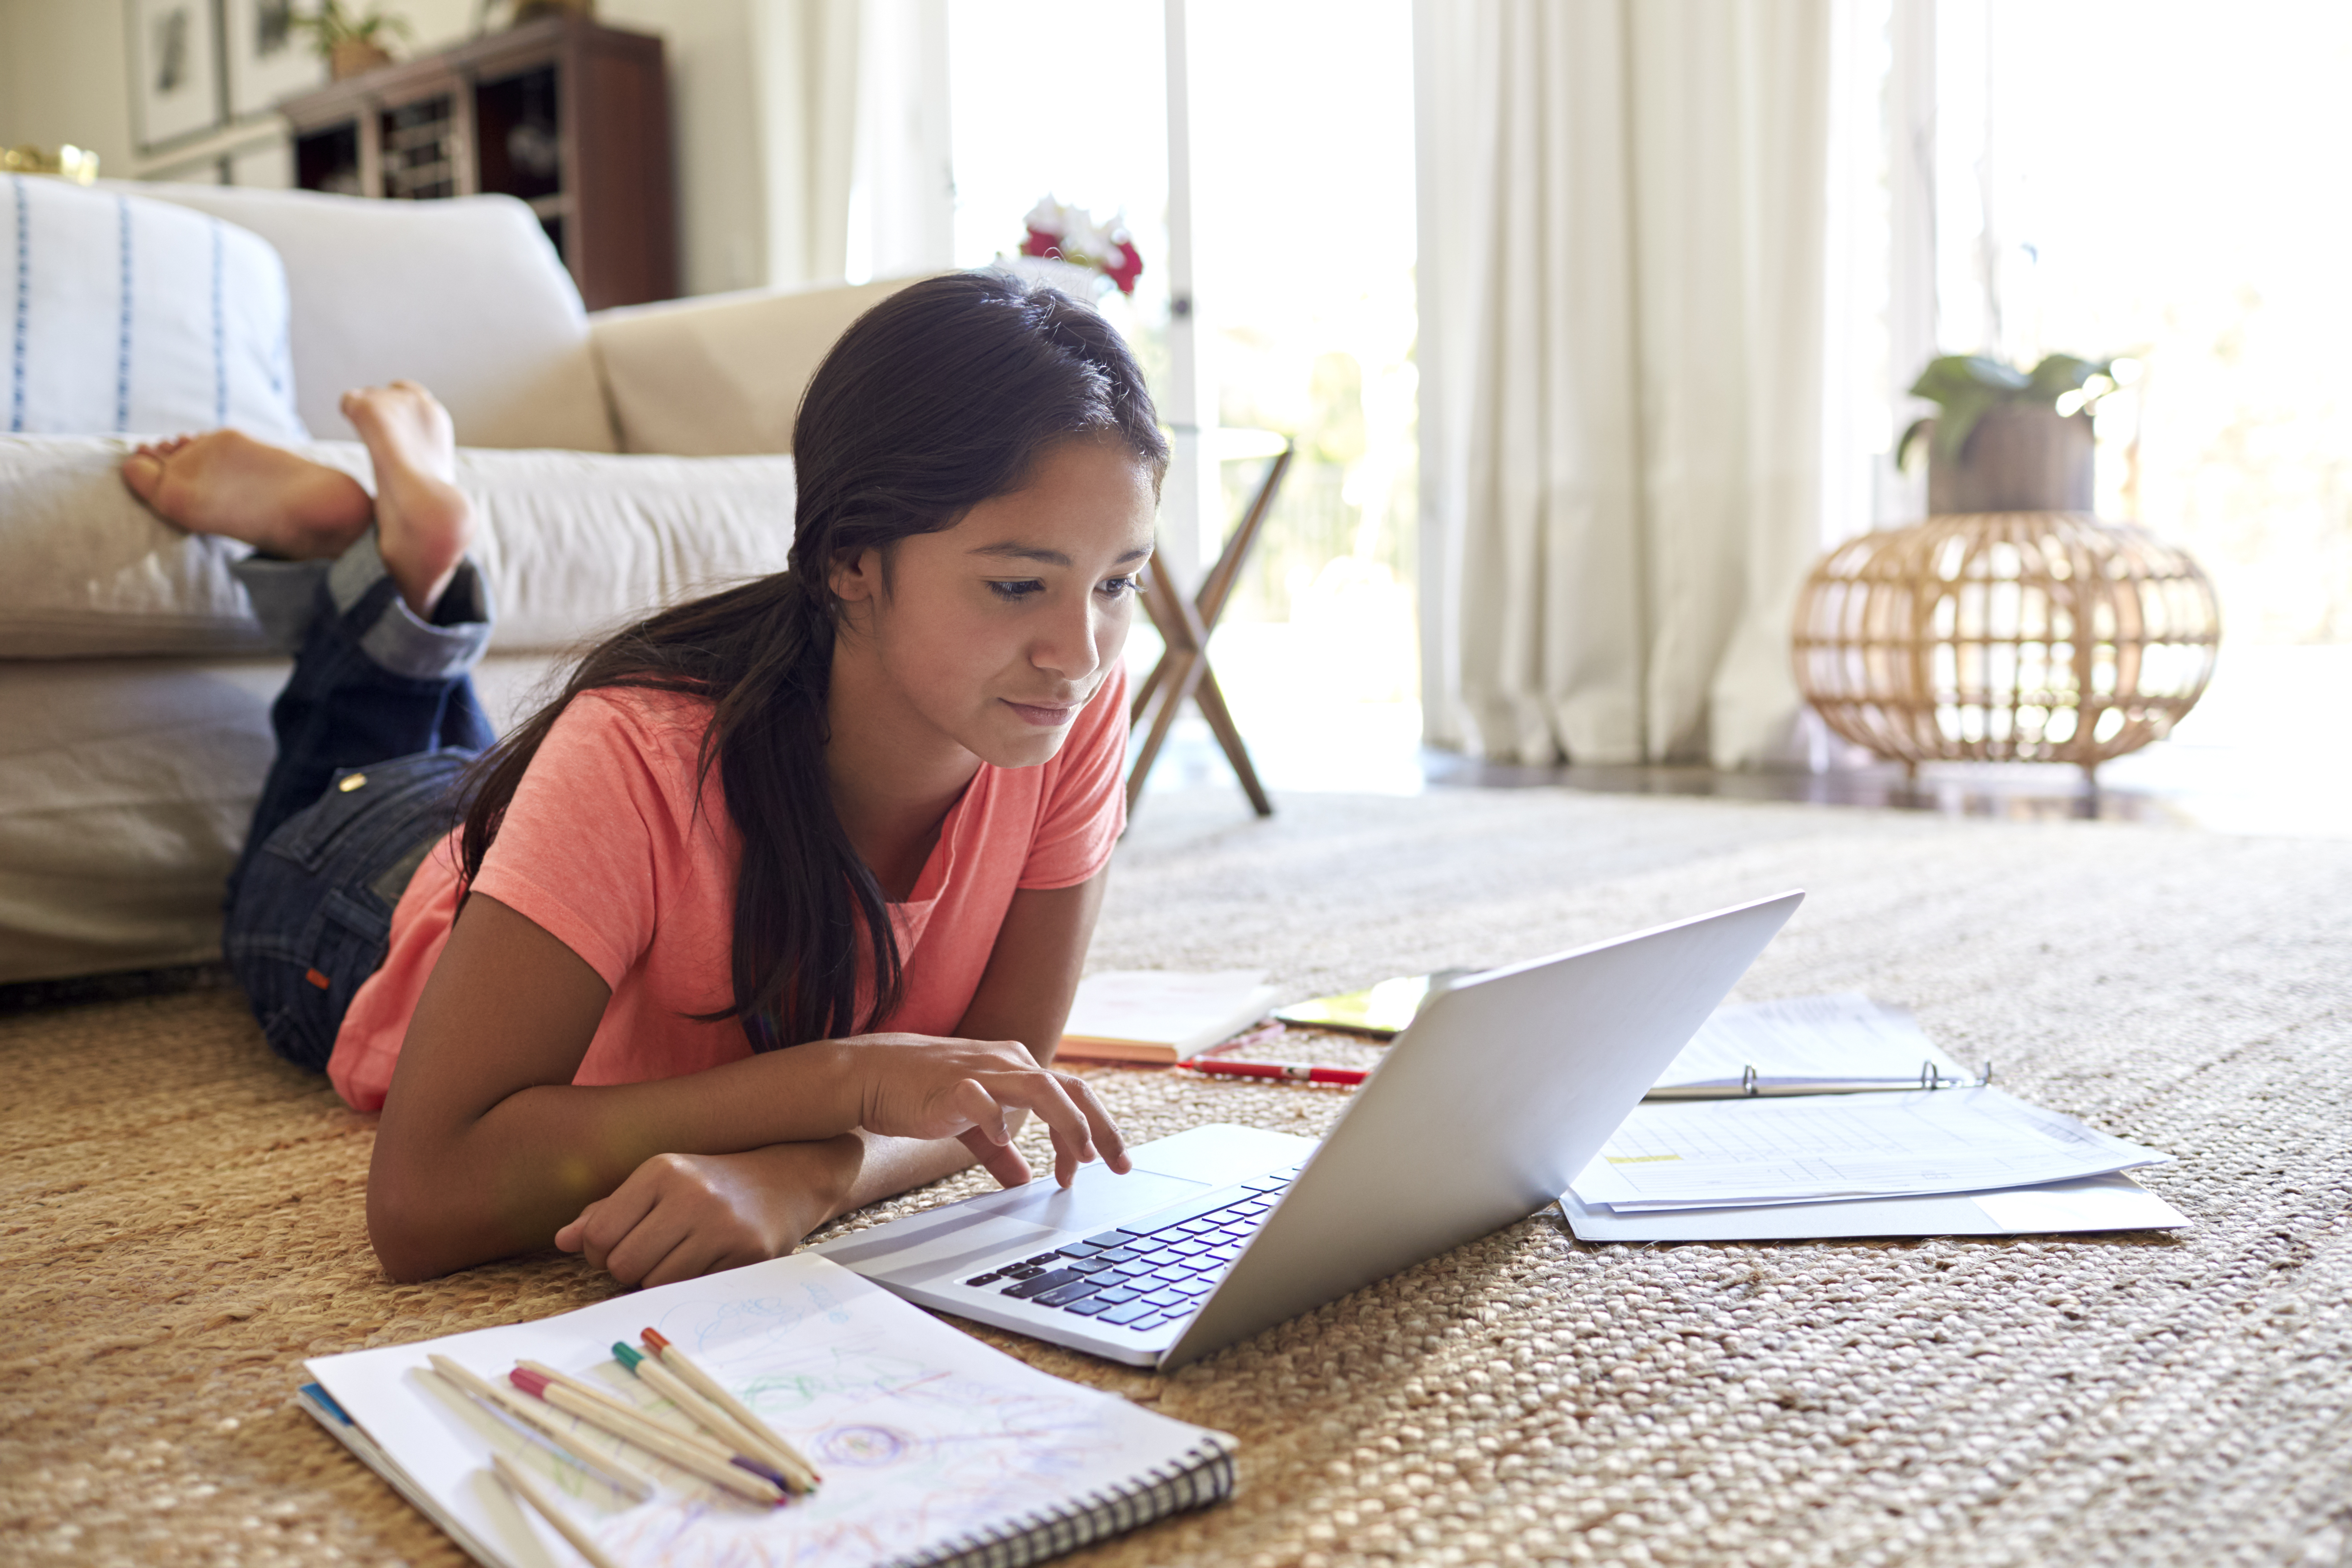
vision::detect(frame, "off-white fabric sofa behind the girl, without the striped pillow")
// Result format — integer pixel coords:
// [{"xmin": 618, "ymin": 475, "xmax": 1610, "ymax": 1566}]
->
[{"xmin": 0, "ymin": 186, "xmax": 917, "ymax": 983}]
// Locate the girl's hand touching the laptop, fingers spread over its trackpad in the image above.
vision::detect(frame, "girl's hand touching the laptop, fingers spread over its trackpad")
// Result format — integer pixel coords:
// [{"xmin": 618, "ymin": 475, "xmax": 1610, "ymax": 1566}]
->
[{"xmin": 830, "ymin": 1034, "xmax": 1129, "ymax": 1187}]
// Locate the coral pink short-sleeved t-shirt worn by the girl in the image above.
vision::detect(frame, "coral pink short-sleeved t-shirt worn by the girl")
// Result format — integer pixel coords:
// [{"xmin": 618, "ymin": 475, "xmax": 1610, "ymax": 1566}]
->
[{"xmin": 327, "ymin": 672, "xmax": 1127, "ymax": 1110}]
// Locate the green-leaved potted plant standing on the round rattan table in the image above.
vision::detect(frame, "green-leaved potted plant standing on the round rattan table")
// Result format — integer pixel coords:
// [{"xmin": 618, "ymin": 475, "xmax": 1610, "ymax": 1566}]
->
[{"xmin": 1896, "ymin": 355, "xmax": 2129, "ymax": 517}]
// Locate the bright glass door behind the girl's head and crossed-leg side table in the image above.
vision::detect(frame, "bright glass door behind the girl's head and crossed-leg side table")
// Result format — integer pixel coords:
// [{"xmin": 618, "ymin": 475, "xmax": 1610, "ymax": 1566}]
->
[{"xmin": 948, "ymin": 0, "xmax": 1421, "ymax": 788}]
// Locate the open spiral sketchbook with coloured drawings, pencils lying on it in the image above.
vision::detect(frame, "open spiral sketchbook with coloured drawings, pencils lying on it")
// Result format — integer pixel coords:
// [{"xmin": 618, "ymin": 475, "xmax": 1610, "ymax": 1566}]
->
[{"xmin": 301, "ymin": 1253, "xmax": 1235, "ymax": 1568}]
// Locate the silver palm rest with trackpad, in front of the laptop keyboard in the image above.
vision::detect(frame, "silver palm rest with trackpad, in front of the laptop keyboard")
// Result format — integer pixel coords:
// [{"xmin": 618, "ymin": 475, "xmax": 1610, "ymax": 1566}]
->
[{"xmin": 818, "ymin": 1164, "xmax": 1209, "ymax": 1277}]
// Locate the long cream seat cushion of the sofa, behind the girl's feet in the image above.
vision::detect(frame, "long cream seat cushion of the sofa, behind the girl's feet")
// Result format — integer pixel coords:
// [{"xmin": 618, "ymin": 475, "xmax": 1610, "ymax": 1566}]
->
[{"xmin": 0, "ymin": 437, "xmax": 793, "ymax": 658}]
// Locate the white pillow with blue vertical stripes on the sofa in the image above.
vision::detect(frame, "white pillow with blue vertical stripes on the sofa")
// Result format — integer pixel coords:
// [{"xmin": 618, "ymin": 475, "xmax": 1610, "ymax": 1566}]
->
[{"xmin": 0, "ymin": 174, "xmax": 306, "ymax": 442}]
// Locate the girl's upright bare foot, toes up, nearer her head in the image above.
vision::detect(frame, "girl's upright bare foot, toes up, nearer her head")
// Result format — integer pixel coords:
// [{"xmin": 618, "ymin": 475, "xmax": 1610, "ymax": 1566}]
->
[{"xmin": 343, "ymin": 381, "xmax": 475, "ymax": 616}]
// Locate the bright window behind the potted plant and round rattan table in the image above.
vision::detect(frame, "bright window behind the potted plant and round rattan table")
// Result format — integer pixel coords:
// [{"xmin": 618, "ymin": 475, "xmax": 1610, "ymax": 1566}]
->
[{"xmin": 1832, "ymin": 0, "xmax": 2352, "ymax": 832}]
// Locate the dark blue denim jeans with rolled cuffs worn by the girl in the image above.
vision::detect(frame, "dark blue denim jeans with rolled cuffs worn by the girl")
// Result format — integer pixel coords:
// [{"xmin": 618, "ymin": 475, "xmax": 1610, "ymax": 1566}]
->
[{"xmin": 221, "ymin": 529, "xmax": 496, "ymax": 1067}]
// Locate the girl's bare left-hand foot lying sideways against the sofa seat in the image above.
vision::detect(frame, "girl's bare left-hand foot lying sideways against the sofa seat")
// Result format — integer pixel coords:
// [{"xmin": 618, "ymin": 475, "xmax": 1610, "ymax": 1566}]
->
[{"xmin": 122, "ymin": 430, "xmax": 374, "ymax": 562}]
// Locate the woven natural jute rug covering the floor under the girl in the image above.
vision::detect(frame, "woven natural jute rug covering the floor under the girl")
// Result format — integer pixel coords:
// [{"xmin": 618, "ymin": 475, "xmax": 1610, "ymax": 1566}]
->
[{"xmin": 14, "ymin": 790, "xmax": 2352, "ymax": 1568}]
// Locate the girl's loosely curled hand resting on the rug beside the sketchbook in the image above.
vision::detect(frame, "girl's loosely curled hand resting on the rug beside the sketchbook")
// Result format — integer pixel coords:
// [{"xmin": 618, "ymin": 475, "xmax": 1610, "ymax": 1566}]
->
[{"xmin": 555, "ymin": 1138, "xmax": 858, "ymax": 1286}]
